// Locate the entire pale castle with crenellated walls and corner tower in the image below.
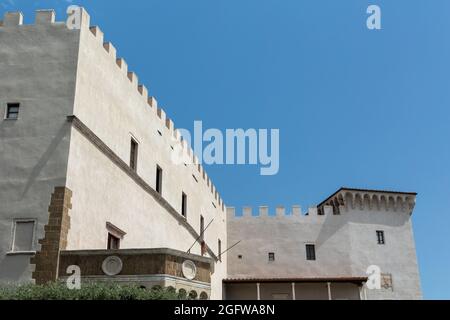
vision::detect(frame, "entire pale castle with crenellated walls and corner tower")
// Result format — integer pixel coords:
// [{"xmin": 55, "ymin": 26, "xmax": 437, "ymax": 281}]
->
[{"xmin": 0, "ymin": 8, "xmax": 421, "ymax": 299}]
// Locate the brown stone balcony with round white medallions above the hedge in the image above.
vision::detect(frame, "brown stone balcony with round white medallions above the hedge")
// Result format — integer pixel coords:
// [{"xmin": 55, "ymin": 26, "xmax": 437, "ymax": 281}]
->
[{"xmin": 58, "ymin": 248, "xmax": 214, "ymax": 299}]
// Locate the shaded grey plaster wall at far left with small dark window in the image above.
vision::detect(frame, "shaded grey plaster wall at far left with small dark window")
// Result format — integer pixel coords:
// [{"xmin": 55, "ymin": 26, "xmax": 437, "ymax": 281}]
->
[{"xmin": 0, "ymin": 13, "xmax": 79, "ymax": 282}]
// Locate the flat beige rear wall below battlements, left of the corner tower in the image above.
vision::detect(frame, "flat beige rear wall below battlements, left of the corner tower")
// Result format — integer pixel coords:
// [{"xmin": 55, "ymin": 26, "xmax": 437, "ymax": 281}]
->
[{"xmin": 228, "ymin": 209, "xmax": 352, "ymax": 278}]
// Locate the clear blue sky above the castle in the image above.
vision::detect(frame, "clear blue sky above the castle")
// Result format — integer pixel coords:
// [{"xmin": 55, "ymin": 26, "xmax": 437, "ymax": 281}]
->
[{"xmin": 0, "ymin": 0, "xmax": 450, "ymax": 299}]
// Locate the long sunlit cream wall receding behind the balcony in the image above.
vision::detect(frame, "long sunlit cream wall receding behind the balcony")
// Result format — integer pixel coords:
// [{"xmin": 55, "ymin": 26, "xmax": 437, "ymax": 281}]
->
[{"xmin": 63, "ymin": 12, "xmax": 227, "ymax": 299}]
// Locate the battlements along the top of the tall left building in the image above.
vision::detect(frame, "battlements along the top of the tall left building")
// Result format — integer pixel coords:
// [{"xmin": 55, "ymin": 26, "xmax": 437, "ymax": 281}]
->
[{"xmin": 0, "ymin": 7, "xmax": 225, "ymax": 211}]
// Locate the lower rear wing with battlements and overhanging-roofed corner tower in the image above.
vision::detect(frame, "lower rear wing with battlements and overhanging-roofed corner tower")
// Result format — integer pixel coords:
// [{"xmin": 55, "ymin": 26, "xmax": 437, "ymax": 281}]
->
[{"xmin": 227, "ymin": 188, "xmax": 421, "ymax": 299}]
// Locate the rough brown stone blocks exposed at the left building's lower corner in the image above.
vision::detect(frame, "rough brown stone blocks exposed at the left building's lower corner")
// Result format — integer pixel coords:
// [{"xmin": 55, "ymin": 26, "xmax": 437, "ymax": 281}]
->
[{"xmin": 30, "ymin": 187, "xmax": 72, "ymax": 284}]
